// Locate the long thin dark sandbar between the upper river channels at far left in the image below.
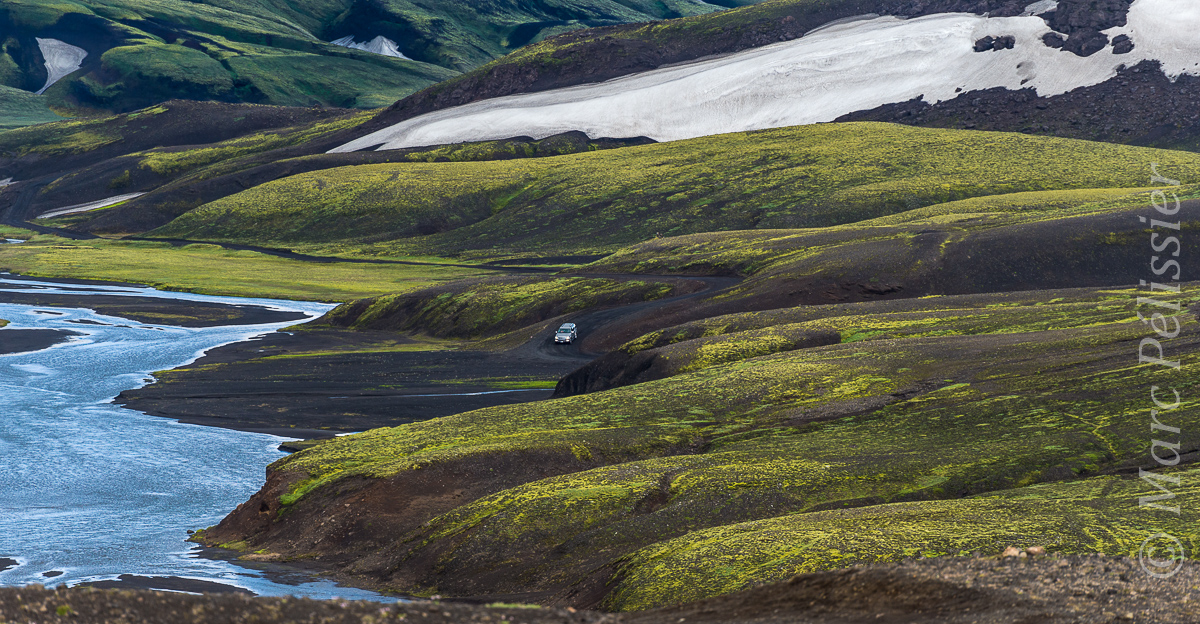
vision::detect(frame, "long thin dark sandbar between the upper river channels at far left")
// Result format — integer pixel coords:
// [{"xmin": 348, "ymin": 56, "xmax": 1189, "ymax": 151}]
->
[{"xmin": 0, "ymin": 288, "xmax": 307, "ymax": 328}]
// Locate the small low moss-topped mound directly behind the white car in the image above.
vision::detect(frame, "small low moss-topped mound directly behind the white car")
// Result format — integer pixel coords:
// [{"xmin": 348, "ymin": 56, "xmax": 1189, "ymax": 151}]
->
[{"xmin": 322, "ymin": 276, "xmax": 703, "ymax": 338}]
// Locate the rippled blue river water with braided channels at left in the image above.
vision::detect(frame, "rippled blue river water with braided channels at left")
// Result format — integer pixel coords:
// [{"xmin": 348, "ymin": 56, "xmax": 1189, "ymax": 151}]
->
[{"xmin": 0, "ymin": 275, "xmax": 382, "ymax": 599}]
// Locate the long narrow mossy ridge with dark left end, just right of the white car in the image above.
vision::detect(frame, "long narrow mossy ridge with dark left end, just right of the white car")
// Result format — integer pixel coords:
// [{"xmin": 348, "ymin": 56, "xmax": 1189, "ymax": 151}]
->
[{"xmin": 557, "ymin": 289, "xmax": 1176, "ymax": 396}]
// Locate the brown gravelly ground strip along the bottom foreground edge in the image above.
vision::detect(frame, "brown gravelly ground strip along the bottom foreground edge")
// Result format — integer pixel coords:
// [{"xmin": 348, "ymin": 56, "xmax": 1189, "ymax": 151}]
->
[{"xmin": 0, "ymin": 556, "xmax": 1200, "ymax": 624}]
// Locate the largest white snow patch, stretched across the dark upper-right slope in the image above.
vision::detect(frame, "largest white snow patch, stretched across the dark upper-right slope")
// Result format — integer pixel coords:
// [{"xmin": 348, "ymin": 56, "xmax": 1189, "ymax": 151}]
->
[{"xmin": 331, "ymin": 0, "xmax": 1200, "ymax": 152}]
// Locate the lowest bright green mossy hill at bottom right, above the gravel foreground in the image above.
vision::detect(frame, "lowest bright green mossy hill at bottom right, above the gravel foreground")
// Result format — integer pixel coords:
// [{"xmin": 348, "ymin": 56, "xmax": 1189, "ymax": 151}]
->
[{"xmin": 604, "ymin": 468, "xmax": 1200, "ymax": 611}]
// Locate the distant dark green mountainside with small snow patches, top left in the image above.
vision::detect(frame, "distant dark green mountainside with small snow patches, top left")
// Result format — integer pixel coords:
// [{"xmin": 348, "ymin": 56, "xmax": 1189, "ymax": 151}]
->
[{"xmin": 0, "ymin": 0, "xmax": 754, "ymax": 119}]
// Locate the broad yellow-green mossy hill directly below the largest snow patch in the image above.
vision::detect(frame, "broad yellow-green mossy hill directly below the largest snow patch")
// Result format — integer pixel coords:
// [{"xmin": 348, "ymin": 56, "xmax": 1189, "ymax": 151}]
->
[{"xmin": 152, "ymin": 124, "xmax": 1200, "ymax": 253}]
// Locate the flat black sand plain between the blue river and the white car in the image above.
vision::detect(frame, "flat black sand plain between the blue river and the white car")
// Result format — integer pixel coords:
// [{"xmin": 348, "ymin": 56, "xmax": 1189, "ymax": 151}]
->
[{"xmin": 116, "ymin": 329, "xmax": 588, "ymax": 438}]
